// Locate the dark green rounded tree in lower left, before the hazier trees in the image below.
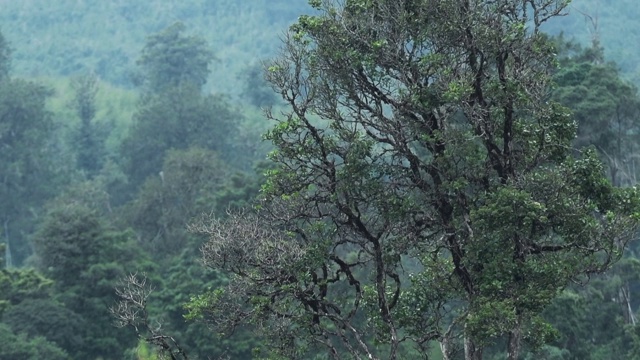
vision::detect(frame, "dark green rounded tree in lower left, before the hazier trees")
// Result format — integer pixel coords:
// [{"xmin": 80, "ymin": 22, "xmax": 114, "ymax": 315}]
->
[{"xmin": 32, "ymin": 201, "xmax": 153, "ymax": 359}]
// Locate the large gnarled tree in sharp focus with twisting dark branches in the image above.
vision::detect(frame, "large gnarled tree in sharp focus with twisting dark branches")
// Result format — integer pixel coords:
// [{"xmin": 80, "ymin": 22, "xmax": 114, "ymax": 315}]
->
[{"xmin": 192, "ymin": 0, "xmax": 640, "ymax": 360}]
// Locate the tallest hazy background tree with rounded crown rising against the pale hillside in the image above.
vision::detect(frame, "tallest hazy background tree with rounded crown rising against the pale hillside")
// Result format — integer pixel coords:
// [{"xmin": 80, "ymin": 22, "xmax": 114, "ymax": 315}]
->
[{"xmin": 121, "ymin": 23, "xmax": 238, "ymax": 188}]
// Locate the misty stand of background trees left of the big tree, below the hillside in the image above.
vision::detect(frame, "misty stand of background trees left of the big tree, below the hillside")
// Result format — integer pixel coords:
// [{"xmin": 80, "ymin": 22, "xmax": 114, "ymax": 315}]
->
[{"xmin": 0, "ymin": 16, "xmax": 264, "ymax": 359}]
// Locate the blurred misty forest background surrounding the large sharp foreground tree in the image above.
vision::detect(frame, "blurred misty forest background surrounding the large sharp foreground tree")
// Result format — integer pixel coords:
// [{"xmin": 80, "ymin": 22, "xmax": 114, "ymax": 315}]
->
[{"xmin": 0, "ymin": 0, "xmax": 640, "ymax": 359}]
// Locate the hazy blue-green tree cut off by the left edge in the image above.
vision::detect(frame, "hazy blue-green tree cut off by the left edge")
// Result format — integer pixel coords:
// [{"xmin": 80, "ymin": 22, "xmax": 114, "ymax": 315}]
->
[{"xmin": 0, "ymin": 79, "xmax": 54, "ymax": 264}]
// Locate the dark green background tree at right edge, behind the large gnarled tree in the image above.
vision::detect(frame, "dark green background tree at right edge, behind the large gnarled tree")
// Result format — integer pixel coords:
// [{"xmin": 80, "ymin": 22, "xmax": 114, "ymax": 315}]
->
[{"xmin": 553, "ymin": 38, "xmax": 640, "ymax": 186}]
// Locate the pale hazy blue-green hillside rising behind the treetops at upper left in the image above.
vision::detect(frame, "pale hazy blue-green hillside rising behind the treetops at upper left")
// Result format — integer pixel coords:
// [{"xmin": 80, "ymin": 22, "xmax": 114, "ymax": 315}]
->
[{"xmin": 0, "ymin": 0, "xmax": 309, "ymax": 95}]
